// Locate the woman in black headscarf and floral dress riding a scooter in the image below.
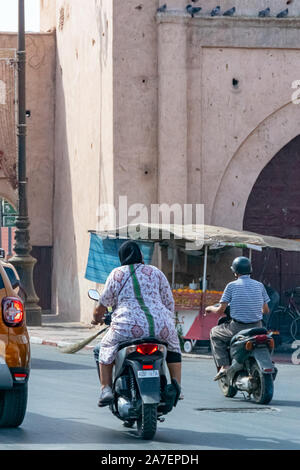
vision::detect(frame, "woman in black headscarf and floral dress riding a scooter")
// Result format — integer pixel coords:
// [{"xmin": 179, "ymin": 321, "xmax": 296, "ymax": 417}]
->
[{"xmin": 94, "ymin": 241, "xmax": 181, "ymax": 406}]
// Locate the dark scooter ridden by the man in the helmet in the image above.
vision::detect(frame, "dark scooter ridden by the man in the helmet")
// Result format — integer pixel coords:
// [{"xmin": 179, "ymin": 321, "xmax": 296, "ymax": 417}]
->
[{"xmin": 214, "ymin": 307, "xmax": 277, "ymax": 404}]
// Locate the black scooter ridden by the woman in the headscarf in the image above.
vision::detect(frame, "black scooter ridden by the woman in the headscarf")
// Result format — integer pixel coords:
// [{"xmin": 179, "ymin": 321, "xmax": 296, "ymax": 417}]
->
[{"xmin": 88, "ymin": 289, "xmax": 180, "ymax": 439}]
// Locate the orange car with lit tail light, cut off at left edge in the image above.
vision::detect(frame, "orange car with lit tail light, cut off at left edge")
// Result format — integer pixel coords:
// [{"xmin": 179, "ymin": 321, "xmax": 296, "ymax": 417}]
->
[{"xmin": 0, "ymin": 255, "xmax": 30, "ymax": 427}]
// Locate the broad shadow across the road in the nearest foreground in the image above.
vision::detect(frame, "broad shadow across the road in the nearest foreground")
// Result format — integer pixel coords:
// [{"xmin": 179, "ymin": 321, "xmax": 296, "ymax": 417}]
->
[{"xmin": 0, "ymin": 413, "xmax": 300, "ymax": 450}]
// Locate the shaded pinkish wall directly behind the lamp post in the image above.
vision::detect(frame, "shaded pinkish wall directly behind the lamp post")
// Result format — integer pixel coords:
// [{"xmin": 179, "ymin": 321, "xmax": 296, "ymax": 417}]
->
[{"xmin": 0, "ymin": 33, "xmax": 55, "ymax": 246}]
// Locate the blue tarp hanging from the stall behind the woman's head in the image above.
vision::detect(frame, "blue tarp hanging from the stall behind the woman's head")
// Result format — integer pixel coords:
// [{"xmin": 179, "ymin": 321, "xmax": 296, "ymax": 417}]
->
[{"xmin": 85, "ymin": 233, "xmax": 154, "ymax": 284}]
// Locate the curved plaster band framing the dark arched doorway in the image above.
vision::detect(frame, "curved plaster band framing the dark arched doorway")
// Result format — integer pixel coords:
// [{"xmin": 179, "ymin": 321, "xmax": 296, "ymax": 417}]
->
[{"xmin": 211, "ymin": 102, "xmax": 300, "ymax": 230}]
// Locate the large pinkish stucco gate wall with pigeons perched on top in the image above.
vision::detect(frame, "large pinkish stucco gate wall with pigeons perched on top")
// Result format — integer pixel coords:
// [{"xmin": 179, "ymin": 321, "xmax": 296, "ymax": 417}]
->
[{"xmin": 42, "ymin": 0, "xmax": 300, "ymax": 320}]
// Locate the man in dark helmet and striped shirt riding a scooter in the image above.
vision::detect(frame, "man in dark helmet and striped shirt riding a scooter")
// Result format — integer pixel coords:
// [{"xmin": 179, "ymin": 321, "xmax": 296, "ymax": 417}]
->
[{"xmin": 205, "ymin": 256, "xmax": 270, "ymax": 380}]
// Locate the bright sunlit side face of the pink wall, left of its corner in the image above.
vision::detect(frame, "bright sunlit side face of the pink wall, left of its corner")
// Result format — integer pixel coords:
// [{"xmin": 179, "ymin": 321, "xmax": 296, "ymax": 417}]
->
[{"xmin": 52, "ymin": 0, "xmax": 114, "ymax": 321}]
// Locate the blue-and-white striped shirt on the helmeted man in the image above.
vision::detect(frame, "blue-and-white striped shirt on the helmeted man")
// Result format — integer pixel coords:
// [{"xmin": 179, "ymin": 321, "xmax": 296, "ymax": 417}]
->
[{"xmin": 220, "ymin": 275, "xmax": 270, "ymax": 323}]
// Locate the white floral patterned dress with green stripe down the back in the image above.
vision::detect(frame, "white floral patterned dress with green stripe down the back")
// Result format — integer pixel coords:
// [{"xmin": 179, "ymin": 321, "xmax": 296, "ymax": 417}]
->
[{"xmin": 99, "ymin": 264, "xmax": 180, "ymax": 364}]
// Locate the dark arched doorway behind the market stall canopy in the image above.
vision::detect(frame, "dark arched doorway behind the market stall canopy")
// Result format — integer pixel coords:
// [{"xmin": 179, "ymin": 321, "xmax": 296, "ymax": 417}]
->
[{"xmin": 243, "ymin": 135, "xmax": 300, "ymax": 302}]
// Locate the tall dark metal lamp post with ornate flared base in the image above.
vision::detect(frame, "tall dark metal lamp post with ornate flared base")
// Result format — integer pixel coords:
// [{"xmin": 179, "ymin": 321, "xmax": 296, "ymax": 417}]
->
[{"xmin": 10, "ymin": 0, "xmax": 42, "ymax": 326}]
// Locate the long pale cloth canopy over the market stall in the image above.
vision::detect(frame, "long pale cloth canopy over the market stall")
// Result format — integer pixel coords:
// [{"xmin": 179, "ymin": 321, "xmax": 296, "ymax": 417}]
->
[{"xmin": 98, "ymin": 223, "xmax": 300, "ymax": 252}]
